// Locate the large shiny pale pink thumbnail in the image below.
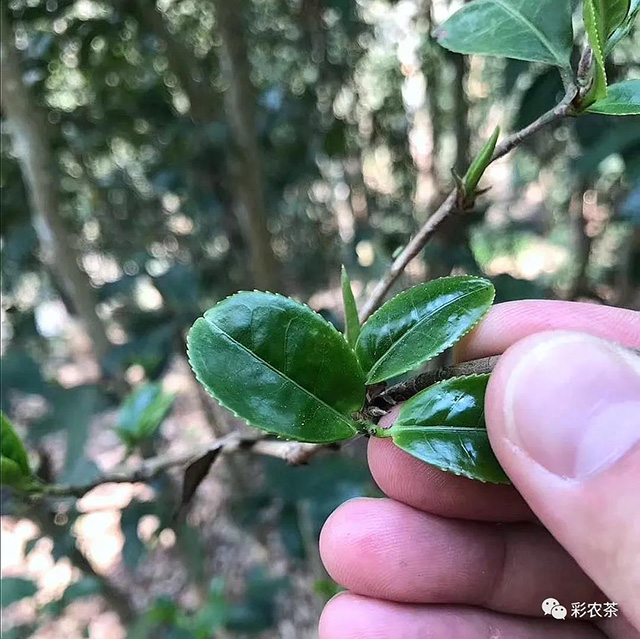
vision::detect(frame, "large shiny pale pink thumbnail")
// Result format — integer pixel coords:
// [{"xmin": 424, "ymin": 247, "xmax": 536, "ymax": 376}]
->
[{"xmin": 504, "ymin": 332, "xmax": 640, "ymax": 479}]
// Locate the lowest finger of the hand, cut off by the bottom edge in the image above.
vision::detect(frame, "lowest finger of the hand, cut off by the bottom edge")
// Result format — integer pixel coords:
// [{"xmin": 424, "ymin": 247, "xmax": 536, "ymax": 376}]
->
[{"xmin": 319, "ymin": 593, "xmax": 604, "ymax": 639}]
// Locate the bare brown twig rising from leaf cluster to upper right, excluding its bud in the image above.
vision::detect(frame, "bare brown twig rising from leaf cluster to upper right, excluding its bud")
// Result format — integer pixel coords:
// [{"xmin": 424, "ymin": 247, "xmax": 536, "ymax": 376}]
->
[{"xmin": 360, "ymin": 86, "xmax": 576, "ymax": 322}]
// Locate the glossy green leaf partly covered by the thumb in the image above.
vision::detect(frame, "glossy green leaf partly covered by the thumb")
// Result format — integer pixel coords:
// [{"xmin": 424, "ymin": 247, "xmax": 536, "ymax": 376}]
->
[{"xmin": 386, "ymin": 375, "xmax": 509, "ymax": 484}]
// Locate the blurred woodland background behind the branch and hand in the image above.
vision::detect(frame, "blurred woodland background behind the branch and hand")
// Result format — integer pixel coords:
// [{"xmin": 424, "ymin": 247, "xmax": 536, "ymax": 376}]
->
[{"xmin": 0, "ymin": 0, "xmax": 640, "ymax": 639}]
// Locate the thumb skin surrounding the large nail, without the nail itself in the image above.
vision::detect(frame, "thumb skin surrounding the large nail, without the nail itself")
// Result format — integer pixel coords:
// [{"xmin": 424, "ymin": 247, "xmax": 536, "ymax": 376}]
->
[{"xmin": 486, "ymin": 332, "xmax": 640, "ymax": 636}]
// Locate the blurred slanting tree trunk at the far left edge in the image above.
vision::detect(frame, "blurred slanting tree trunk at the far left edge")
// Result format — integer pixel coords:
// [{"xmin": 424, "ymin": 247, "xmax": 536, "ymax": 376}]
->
[{"xmin": 0, "ymin": 15, "xmax": 110, "ymax": 358}]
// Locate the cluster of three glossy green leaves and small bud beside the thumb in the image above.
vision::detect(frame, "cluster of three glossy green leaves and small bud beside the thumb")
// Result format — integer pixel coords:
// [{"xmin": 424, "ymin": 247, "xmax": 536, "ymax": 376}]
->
[{"xmin": 188, "ymin": 276, "xmax": 506, "ymax": 481}]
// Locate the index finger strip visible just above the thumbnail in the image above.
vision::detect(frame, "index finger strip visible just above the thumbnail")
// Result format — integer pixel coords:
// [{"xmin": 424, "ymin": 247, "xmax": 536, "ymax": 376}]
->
[{"xmin": 455, "ymin": 300, "xmax": 640, "ymax": 362}]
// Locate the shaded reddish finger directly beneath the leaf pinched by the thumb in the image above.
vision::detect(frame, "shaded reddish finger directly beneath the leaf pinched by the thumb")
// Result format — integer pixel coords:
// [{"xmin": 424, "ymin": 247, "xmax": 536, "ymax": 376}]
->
[{"xmin": 368, "ymin": 437, "xmax": 536, "ymax": 522}]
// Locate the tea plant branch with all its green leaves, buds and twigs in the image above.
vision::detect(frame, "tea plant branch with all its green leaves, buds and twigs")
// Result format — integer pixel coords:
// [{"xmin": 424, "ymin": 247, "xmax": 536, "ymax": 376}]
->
[{"xmin": 1, "ymin": 0, "xmax": 640, "ymax": 497}]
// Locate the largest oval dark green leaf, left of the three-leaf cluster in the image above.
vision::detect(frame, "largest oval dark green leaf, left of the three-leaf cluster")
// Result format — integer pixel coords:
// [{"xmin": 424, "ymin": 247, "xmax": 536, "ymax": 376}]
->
[{"xmin": 188, "ymin": 291, "xmax": 365, "ymax": 443}]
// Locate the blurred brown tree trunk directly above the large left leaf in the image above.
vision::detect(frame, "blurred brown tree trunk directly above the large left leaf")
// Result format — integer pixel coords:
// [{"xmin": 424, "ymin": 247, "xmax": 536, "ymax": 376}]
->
[{"xmin": 215, "ymin": 0, "xmax": 280, "ymax": 291}]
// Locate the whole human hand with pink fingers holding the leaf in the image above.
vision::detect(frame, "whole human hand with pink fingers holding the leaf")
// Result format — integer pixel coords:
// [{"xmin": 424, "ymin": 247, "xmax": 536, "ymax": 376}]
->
[{"xmin": 320, "ymin": 302, "xmax": 640, "ymax": 639}]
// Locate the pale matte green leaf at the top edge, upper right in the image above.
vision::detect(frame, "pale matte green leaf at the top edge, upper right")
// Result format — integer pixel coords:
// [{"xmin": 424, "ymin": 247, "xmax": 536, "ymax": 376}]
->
[{"xmin": 435, "ymin": 0, "xmax": 573, "ymax": 69}]
